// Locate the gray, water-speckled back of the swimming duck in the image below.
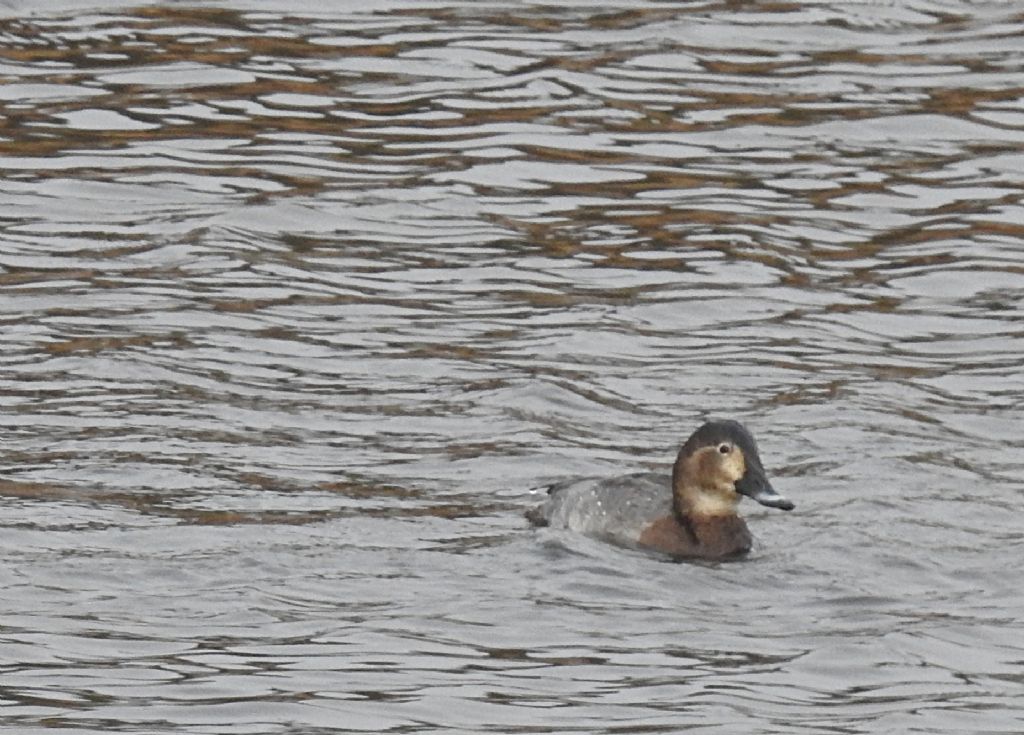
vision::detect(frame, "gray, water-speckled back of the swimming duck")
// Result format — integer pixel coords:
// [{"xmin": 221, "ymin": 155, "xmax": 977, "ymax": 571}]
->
[{"xmin": 540, "ymin": 472, "xmax": 672, "ymax": 544}]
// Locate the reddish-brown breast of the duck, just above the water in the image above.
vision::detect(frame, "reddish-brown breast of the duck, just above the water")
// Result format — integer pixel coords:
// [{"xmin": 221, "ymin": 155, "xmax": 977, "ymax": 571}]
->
[{"xmin": 639, "ymin": 515, "xmax": 753, "ymax": 559}]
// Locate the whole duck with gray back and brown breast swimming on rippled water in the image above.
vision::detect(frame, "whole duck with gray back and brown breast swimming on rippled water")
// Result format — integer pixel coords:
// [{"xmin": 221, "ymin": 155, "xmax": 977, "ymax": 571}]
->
[{"xmin": 526, "ymin": 420, "xmax": 795, "ymax": 561}]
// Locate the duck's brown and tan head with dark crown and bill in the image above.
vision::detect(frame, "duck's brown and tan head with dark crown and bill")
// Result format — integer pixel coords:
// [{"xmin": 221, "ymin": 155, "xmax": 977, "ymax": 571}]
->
[{"xmin": 672, "ymin": 421, "xmax": 794, "ymax": 516}]
